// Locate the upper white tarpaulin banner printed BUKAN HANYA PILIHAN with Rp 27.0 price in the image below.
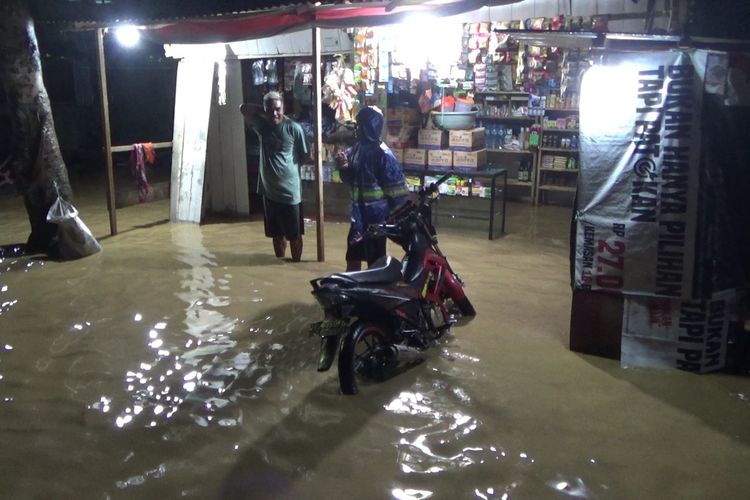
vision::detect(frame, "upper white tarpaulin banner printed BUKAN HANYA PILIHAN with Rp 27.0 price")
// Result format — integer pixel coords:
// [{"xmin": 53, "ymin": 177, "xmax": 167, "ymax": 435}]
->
[{"xmin": 575, "ymin": 50, "xmax": 707, "ymax": 298}]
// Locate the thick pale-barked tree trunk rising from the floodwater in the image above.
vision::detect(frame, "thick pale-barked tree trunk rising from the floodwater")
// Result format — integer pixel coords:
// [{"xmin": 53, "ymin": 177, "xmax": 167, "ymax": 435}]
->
[{"xmin": 0, "ymin": 0, "xmax": 99, "ymax": 257}]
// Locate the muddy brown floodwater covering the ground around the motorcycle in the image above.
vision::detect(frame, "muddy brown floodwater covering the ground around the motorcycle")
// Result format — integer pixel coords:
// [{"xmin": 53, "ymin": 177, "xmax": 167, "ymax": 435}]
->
[{"xmin": 0, "ymin": 184, "xmax": 750, "ymax": 500}]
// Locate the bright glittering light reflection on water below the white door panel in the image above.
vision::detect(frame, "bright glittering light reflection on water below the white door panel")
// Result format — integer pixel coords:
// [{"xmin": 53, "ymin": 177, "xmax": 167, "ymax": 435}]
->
[{"xmin": 90, "ymin": 224, "xmax": 251, "ymax": 430}]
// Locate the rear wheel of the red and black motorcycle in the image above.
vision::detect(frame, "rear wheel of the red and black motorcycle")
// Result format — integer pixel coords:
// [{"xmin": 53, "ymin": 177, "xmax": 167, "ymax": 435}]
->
[{"xmin": 339, "ymin": 321, "xmax": 396, "ymax": 394}]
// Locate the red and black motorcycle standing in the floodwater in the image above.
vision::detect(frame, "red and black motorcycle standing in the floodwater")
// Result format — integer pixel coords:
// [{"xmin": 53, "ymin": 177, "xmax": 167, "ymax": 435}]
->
[{"xmin": 310, "ymin": 172, "xmax": 476, "ymax": 394}]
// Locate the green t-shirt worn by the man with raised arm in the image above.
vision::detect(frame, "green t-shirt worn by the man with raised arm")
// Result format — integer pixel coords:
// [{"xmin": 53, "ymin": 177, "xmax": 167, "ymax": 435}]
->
[{"xmin": 255, "ymin": 117, "xmax": 307, "ymax": 205}]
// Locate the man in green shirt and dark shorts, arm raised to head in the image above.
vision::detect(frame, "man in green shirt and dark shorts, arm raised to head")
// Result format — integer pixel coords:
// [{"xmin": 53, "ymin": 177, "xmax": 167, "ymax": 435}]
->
[{"xmin": 240, "ymin": 92, "xmax": 309, "ymax": 262}]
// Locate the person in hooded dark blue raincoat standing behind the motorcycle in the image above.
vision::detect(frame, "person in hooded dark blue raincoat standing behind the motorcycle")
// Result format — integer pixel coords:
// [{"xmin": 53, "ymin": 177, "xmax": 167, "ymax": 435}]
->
[{"xmin": 335, "ymin": 106, "xmax": 409, "ymax": 271}]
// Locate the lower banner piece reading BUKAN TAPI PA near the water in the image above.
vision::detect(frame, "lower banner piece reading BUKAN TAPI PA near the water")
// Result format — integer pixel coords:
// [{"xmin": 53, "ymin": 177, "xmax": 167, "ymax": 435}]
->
[{"xmin": 620, "ymin": 290, "xmax": 736, "ymax": 373}]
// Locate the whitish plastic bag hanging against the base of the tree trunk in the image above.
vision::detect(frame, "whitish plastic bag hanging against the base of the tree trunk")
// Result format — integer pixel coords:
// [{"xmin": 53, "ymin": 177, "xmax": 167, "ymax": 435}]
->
[{"xmin": 47, "ymin": 194, "xmax": 102, "ymax": 260}]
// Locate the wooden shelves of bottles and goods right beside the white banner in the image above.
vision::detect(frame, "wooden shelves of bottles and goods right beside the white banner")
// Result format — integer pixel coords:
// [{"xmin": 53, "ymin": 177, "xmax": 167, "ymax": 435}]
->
[{"xmin": 534, "ymin": 108, "xmax": 579, "ymax": 204}]
